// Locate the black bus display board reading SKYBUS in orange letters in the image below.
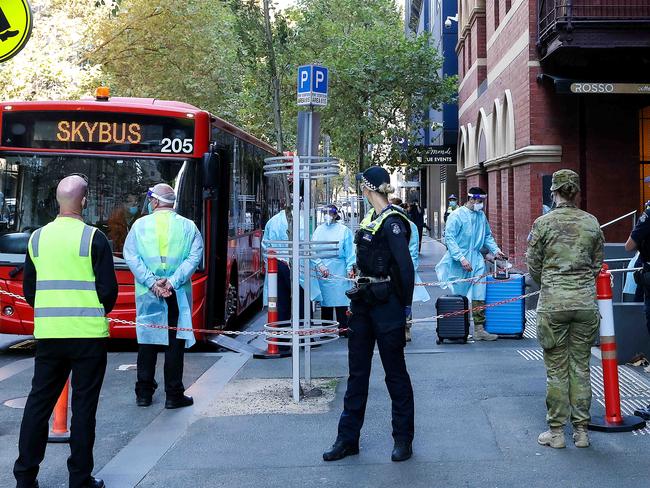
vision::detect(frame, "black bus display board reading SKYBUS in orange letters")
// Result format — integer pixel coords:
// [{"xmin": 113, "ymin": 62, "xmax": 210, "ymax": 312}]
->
[{"xmin": 1, "ymin": 111, "xmax": 194, "ymax": 155}]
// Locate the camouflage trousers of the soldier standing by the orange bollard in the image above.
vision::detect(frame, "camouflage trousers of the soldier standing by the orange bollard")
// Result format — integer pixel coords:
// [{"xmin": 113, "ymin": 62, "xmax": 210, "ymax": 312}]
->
[{"xmin": 537, "ymin": 310, "xmax": 600, "ymax": 427}]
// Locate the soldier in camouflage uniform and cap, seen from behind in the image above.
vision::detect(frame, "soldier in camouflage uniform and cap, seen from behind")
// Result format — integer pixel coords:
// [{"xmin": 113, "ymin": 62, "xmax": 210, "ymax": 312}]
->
[{"xmin": 527, "ymin": 169, "xmax": 604, "ymax": 448}]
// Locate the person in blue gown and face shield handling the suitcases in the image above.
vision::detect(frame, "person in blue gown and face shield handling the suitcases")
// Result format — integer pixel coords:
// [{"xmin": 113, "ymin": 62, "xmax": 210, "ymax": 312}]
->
[{"xmin": 436, "ymin": 187, "xmax": 506, "ymax": 341}]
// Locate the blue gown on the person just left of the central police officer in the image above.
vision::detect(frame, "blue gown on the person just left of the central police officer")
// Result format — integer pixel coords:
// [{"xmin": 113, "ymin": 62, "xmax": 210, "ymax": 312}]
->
[{"xmin": 312, "ymin": 222, "xmax": 356, "ymax": 307}]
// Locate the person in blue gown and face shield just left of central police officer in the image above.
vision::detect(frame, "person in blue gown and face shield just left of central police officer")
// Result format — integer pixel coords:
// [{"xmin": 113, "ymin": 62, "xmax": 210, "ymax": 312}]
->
[{"xmin": 312, "ymin": 205, "xmax": 356, "ymax": 336}]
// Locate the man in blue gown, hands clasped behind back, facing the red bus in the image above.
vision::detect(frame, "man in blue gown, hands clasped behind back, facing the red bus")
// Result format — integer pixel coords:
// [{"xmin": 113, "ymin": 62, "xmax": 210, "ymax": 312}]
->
[{"xmin": 124, "ymin": 183, "xmax": 203, "ymax": 408}]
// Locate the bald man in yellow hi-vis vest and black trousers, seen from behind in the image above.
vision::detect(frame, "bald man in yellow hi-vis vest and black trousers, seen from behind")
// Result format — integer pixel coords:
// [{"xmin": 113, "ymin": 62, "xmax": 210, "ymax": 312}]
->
[{"xmin": 14, "ymin": 175, "xmax": 118, "ymax": 488}]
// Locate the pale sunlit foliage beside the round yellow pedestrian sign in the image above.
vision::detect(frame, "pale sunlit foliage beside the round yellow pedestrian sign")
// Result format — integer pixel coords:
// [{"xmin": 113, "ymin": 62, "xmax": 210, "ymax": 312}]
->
[{"xmin": 0, "ymin": 0, "xmax": 115, "ymax": 100}]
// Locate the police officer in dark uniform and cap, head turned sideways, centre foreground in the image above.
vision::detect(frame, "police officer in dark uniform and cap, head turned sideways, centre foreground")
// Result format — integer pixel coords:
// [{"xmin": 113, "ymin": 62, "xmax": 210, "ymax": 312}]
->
[{"xmin": 323, "ymin": 166, "xmax": 414, "ymax": 461}]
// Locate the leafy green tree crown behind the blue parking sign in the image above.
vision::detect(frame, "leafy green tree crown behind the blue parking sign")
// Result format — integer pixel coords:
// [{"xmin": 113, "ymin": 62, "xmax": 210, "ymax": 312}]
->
[{"xmin": 283, "ymin": 0, "xmax": 455, "ymax": 169}]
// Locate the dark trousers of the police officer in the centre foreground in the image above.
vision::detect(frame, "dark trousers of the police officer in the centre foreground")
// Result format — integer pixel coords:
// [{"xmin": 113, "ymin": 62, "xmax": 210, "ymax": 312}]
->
[{"xmin": 337, "ymin": 295, "xmax": 415, "ymax": 444}]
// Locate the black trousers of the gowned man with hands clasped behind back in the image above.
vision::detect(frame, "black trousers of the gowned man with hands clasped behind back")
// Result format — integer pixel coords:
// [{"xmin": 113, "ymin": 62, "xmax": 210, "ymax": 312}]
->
[{"xmin": 135, "ymin": 293, "xmax": 185, "ymax": 399}]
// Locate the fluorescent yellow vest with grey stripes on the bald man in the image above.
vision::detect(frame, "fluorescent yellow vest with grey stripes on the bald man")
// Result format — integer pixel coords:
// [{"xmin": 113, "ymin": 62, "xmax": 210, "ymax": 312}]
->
[{"xmin": 28, "ymin": 217, "xmax": 108, "ymax": 339}]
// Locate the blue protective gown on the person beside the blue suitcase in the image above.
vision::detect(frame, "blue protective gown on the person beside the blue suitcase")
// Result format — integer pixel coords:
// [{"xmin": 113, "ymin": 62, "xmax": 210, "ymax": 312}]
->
[{"xmin": 436, "ymin": 206, "xmax": 500, "ymax": 300}]
